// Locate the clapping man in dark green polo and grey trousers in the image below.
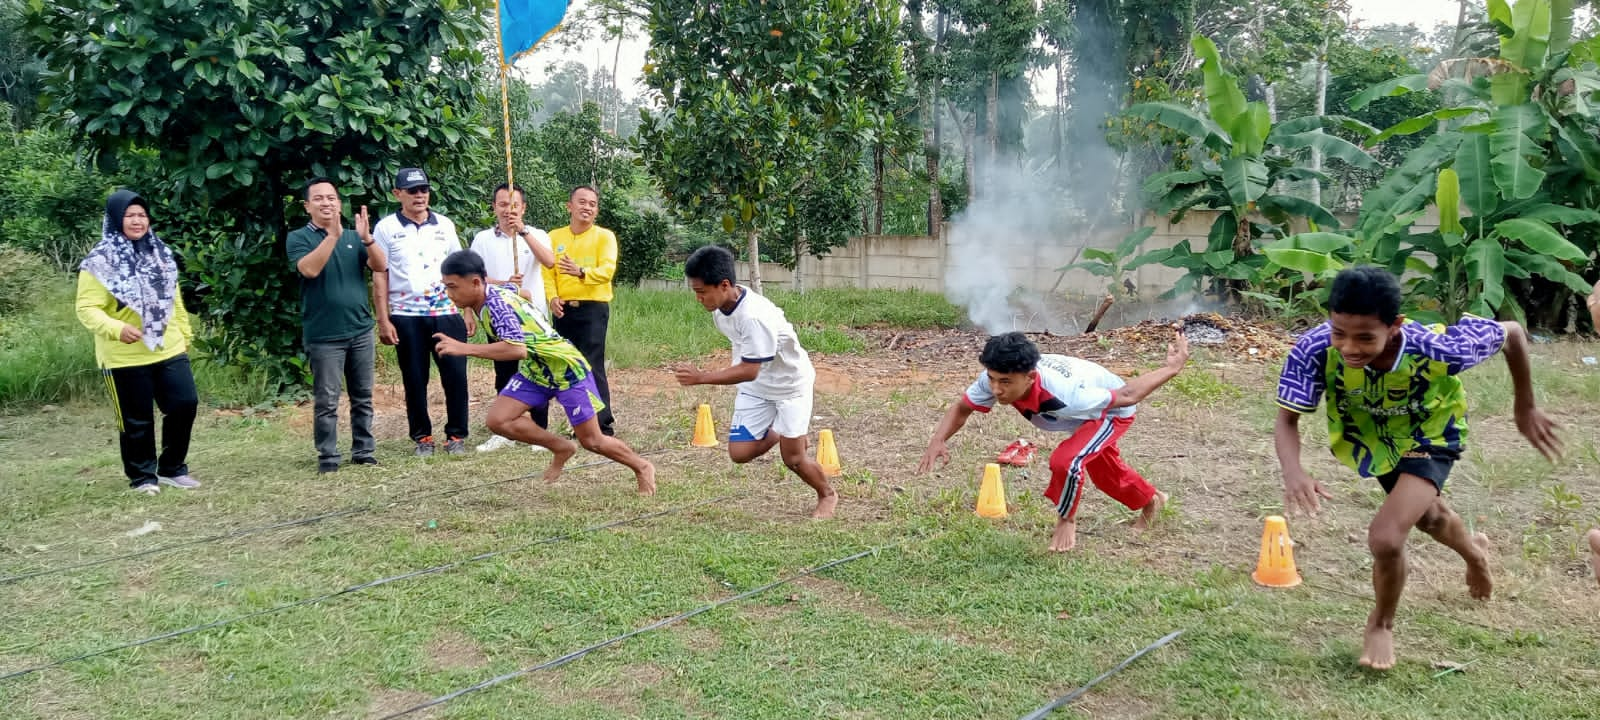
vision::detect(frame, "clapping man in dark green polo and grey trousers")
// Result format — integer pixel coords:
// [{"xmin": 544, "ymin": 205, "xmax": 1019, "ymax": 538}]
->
[{"xmin": 288, "ymin": 178, "xmax": 389, "ymax": 474}]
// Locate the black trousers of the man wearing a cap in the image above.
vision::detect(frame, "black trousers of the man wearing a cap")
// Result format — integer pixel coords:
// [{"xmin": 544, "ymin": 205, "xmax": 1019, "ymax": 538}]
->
[{"xmin": 389, "ymin": 315, "xmax": 467, "ymax": 442}]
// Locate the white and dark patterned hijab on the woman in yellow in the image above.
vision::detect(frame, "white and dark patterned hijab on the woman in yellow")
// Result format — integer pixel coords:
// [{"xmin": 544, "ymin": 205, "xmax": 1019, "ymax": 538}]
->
[{"xmin": 82, "ymin": 190, "xmax": 178, "ymax": 350}]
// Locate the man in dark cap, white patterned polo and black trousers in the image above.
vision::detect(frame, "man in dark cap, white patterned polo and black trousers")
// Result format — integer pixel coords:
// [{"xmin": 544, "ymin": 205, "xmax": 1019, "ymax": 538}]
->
[{"xmin": 373, "ymin": 168, "xmax": 477, "ymax": 458}]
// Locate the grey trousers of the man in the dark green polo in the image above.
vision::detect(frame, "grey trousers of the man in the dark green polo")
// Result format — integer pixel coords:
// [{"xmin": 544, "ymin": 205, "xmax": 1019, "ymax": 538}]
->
[{"xmin": 306, "ymin": 331, "xmax": 378, "ymax": 466}]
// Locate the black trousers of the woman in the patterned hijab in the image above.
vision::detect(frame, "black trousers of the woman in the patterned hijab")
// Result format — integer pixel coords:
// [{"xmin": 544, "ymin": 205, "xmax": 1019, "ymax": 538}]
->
[{"xmin": 101, "ymin": 355, "xmax": 200, "ymax": 486}]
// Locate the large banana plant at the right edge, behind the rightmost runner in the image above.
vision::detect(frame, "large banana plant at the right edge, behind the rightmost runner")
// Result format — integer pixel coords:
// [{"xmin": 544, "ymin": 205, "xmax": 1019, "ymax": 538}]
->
[{"xmin": 1350, "ymin": 0, "xmax": 1600, "ymax": 325}]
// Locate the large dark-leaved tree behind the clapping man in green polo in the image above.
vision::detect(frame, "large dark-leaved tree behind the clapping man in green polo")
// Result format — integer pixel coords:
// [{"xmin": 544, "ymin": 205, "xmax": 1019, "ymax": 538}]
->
[{"xmin": 26, "ymin": 0, "xmax": 490, "ymax": 388}]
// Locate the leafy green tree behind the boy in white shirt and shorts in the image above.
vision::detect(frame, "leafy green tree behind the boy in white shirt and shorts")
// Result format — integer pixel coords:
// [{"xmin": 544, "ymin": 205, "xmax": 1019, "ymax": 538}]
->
[{"xmin": 637, "ymin": 0, "xmax": 902, "ymax": 286}]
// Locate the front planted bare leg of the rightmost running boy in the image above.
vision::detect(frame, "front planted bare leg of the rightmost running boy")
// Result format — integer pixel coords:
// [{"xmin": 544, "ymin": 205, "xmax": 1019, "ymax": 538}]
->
[{"xmin": 1360, "ymin": 474, "xmax": 1438, "ymax": 670}]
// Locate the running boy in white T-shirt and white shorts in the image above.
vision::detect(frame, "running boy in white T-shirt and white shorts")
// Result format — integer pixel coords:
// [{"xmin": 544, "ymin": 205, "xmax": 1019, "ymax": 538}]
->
[{"xmin": 674, "ymin": 245, "xmax": 838, "ymax": 520}]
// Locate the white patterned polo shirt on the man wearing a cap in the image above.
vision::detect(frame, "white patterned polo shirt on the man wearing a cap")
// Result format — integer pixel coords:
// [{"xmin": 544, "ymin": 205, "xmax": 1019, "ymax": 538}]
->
[{"xmin": 373, "ymin": 211, "xmax": 461, "ymax": 317}]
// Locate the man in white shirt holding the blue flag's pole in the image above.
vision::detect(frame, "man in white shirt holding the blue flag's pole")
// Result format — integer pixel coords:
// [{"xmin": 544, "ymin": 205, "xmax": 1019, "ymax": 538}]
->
[{"xmin": 470, "ymin": 182, "xmax": 555, "ymax": 453}]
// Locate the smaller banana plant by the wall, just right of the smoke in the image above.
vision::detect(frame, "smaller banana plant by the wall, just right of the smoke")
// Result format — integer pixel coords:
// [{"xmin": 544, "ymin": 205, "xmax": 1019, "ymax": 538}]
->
[{"xmin": 1126, "ymin": 35, "xmax": 1379, "ymax": 296}]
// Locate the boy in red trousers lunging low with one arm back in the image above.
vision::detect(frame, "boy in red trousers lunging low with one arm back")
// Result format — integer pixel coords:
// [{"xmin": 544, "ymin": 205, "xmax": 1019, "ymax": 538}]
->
[{"xmin": 917, "ymin": 333, "xmax": 1189, "ymax": 552}]
